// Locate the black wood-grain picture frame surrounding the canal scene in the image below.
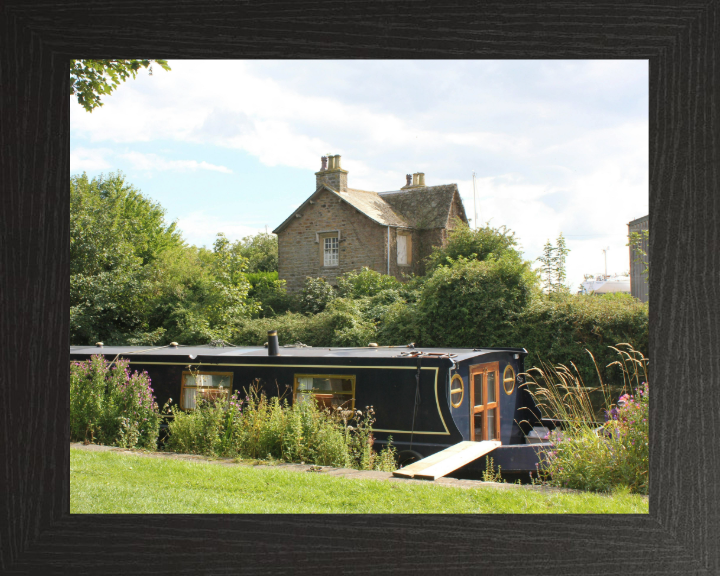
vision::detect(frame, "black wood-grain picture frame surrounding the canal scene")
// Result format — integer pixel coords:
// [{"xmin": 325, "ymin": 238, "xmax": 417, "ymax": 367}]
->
[{"xmin": 0, "ymin": 0, "xmax": 720, "ymax": 576}]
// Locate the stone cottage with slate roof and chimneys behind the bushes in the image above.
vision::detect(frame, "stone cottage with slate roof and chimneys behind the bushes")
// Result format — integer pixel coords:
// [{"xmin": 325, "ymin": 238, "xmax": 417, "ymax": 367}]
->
[{"xmin": 273, "ymin": 156, "xmax": 467, "ymax": 292}]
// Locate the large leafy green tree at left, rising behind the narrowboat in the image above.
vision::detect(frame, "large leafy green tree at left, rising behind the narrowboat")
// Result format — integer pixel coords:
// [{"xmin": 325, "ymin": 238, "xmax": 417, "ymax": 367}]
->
[{"xmin": 70, "ymin": 172, "xmax": 183, "ymax": 344}]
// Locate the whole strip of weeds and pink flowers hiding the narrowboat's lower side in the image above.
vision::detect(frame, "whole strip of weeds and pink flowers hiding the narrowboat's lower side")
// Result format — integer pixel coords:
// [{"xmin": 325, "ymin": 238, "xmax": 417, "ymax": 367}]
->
[{"xmin": 70, "ymin": 356, "xmax": 396, "ymax": 471}]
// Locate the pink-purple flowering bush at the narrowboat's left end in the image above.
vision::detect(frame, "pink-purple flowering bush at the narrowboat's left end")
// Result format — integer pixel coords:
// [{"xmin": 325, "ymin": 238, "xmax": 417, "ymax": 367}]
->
[{"xmin": 70, "ymin": 355, "xmax": 161, "ymax": 449}]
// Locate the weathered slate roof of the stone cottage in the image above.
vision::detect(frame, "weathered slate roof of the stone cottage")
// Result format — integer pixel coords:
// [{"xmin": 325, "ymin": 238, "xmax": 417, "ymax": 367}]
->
[{"xmin": 273, "ymin": 184, "xmax": 467, "ymax": 234}]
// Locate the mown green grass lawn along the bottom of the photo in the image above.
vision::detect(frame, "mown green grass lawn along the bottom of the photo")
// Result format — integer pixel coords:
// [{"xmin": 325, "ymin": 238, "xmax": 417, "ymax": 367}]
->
[{"xmin": 70, "ymin": 448, "xmax": 648, "ymax": 514}]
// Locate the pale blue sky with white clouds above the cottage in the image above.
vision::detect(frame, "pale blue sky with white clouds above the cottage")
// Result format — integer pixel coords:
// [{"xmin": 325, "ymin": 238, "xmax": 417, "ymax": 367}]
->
[{"xmin": 70, "ymin": 60, "xmax": 649, "ymax": 292}]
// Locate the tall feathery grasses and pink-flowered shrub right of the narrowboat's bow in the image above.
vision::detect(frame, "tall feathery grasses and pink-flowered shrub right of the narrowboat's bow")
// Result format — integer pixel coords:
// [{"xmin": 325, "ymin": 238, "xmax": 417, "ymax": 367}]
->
[{"xmin": 529, "ymin": 345, "xmax": 649, "ymax": 494}]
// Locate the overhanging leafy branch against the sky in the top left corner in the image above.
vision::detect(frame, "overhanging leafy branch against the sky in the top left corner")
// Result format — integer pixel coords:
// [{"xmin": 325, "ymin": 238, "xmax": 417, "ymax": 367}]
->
[{"xmin": 70, "ymin": 60, "xmax": 170, "ymax": 112}]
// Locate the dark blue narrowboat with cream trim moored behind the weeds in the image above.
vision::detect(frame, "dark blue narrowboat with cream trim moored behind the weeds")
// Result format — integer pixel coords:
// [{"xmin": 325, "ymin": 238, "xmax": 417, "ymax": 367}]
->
[{"xmin": 70, "ymin": 333, "xmax": 551, "ymax": 475}]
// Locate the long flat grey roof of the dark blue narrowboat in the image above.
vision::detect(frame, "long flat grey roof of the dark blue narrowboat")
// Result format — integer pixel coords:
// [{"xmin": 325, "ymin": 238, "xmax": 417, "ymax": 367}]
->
[{"xmin": 70, "ymin": 345, "xmax": 527, "ymax": 362}]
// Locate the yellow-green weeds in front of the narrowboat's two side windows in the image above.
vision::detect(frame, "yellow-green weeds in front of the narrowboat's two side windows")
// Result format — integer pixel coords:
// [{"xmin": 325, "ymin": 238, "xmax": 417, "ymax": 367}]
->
[{"xmin": 166, "ymin": 386, "xmax": 395, "ymax": 470}]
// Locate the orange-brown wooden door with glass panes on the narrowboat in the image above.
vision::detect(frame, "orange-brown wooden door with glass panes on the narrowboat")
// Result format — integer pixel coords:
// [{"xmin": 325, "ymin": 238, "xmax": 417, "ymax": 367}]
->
[{"xmin": 470, "ymin": 362, "xmax": 500, "ymax": 442}]
